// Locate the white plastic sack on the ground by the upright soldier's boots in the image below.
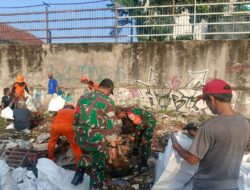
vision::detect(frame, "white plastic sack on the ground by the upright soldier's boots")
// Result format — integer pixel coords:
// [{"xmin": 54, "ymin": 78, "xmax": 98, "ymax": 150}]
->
[{"xmin": 37, "ymin": 158, "xmax": 89, "ymax": 190}]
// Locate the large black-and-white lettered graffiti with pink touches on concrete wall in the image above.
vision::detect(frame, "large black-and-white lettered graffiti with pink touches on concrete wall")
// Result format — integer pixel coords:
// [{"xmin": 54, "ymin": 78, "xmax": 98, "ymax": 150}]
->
[{"xmin": 115, "ymin": 68, "xmax": 208, "ymax": 112}]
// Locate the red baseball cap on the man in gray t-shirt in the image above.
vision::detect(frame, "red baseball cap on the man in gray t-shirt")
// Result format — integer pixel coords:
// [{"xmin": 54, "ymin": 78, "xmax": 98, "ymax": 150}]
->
[{"xmin": 198, "ymin": 79, "xmax": 232, "ymax": 100}]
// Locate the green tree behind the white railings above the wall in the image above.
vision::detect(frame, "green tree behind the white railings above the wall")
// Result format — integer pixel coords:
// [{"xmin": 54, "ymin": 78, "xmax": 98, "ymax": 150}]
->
[{"xmin": 111, "ymin": 0, "xmax": 238, "ymax": 41}]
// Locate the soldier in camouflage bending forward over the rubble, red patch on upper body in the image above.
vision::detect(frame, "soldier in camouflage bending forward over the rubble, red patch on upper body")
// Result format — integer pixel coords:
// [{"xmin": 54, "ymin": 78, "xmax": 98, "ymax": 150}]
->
[{"xmin": 116, "ymin": 107, "xmax": 156, "ymax": 172}]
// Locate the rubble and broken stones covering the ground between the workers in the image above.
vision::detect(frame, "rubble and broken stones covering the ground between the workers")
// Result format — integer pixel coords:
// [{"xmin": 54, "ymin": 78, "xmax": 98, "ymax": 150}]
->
[{"xmin": 0, "ymin": 109, "xmax": 246, "ymax": 190}]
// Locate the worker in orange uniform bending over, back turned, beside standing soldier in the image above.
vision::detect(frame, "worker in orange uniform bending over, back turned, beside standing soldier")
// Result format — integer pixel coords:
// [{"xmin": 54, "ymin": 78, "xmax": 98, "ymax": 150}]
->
[{"xmin": 48, "ymin": 105, "xmax": 82, "ymax": 164}]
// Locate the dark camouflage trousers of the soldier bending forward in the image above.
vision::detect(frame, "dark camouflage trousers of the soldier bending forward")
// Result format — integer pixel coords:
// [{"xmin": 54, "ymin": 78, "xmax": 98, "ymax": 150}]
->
[{"xmin": 134, "ymin": 118, "xmax": 156, "ymax": 160}]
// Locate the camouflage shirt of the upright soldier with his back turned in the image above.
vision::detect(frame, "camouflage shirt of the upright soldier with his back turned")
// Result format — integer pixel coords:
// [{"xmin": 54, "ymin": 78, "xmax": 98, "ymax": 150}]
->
[{"xmin": 74, "ymin": 91, "xmax": 116, "ymax": 151}]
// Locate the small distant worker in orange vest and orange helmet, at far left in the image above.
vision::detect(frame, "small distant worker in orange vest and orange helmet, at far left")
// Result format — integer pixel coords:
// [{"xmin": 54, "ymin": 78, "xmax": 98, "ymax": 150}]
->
[{"xmin": 11, "ymin": 75, "xmax": 29, "ymax": 101}]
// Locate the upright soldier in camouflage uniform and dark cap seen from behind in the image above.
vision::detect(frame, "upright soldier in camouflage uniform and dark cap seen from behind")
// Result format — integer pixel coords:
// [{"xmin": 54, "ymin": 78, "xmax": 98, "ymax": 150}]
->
[{"xmin": 71, "ymin": 79, "xmax": 116, "ymax": 189}]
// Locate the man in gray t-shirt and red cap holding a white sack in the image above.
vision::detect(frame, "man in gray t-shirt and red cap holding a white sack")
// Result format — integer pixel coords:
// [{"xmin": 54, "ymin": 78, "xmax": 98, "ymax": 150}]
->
[{"xmin": 172, "ymin": 79, "xmax": 250, "ymax": 190}]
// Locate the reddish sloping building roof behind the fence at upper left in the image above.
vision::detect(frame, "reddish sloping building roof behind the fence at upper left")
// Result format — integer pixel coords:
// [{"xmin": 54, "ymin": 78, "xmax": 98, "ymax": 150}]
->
[{"xmin": 0, "ymin": 23, "xmax": 43, "ymax": 45}]
